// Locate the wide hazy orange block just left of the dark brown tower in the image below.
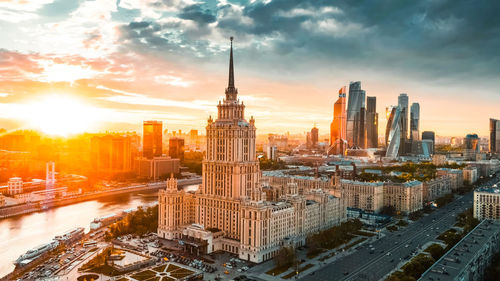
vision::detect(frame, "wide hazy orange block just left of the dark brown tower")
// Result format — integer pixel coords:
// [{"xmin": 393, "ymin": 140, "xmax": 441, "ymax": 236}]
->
[{"xmin": 90, "ymin": 135, "xmax": 132, "ymax": 175}]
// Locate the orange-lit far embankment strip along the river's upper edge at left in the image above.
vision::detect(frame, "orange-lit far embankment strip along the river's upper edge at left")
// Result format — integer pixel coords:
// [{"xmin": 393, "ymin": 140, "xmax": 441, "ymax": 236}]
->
[{"xmin": 0, "ymin": 178, "xmax": 201, "ymax": 219}]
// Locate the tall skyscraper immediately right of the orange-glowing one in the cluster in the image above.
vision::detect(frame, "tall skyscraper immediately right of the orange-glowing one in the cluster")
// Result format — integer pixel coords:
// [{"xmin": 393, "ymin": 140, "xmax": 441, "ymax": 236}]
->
[{"xmin": 346, "ymin": 81, "xmax": 366, "ymax": 147}]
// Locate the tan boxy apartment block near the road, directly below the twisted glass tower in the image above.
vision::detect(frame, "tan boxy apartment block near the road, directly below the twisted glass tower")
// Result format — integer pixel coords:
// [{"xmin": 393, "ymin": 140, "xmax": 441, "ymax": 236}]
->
[{"xmin": 383, "ymin": 180, "xmax": 423, "ymax": 214}]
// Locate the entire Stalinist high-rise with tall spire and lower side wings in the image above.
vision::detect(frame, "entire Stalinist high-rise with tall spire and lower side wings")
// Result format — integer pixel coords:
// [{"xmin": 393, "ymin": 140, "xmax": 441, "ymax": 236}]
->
[{"xmin": 158, "ymin": 38, "xmax": 346, "ymax": 263}]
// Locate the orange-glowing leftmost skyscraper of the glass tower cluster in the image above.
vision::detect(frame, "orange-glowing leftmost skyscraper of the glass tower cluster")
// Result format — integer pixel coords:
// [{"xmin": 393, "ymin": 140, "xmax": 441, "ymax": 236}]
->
[{"xmin": 330, "ymin": 86, "xmax": 347, "ymax": 148}]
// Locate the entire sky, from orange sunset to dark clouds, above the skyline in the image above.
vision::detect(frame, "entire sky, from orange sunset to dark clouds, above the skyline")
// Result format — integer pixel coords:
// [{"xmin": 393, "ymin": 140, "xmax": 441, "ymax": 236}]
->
[{"xmin": 0, "ymin": 0, "xmax": 500, "ymax": 136}]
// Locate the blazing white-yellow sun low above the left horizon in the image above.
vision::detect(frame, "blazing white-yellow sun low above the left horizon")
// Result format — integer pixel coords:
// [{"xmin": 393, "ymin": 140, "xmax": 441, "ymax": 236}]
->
[{"xmin": 23, "ymin": 94, "xmax": 98, "ymax": 136}]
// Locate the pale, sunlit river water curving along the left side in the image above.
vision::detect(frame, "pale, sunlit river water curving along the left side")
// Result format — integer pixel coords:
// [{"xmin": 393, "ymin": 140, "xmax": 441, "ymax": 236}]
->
[{"xmin": 0, "ymin": 186, "xmax": 187, "ymax": 277}]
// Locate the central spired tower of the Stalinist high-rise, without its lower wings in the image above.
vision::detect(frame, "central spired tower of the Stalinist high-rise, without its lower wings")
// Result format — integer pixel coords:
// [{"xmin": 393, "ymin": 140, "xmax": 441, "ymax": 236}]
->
[{"xmin": 196, "ymin": 37, "xmax": 260, "ymax": 239}]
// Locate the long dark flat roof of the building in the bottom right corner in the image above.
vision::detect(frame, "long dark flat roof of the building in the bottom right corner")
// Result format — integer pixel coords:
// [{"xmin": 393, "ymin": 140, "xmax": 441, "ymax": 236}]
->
[{"xmin": 418, "ymin": 220, "xmax": 500, "ymax": 281}]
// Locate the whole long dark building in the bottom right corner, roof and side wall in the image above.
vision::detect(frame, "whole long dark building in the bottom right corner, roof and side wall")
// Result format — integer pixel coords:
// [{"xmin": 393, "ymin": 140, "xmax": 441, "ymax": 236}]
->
[{"xmin": 418, "ymin": 220, "xmax": 500, "ymax": 281}]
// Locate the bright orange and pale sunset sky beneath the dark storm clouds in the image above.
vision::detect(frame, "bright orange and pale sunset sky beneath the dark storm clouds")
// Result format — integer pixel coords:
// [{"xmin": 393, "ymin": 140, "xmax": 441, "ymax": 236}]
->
[{"xmin": 0, "ymin": 0, "xmax": 500, "ymax": 136}]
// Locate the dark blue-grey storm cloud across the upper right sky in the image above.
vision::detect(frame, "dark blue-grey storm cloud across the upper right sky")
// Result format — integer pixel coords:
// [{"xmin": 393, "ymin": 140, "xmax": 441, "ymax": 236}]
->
[{"xmin": 116, "ymin": 0, "xmax": 500, "ymax": 81}]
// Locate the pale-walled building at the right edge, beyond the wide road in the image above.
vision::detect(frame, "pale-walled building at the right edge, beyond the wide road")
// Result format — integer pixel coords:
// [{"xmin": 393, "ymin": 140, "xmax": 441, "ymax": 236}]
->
[{"xmin": 474, "ymin": 187, "xmax": 500, "ymax": 220}]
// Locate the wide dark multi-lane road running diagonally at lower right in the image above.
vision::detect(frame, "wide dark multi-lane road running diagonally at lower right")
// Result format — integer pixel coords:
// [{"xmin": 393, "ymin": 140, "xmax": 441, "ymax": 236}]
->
[{"xmin": 301, "ymin": 173, "xmax": 500, "ymax": 281}]
